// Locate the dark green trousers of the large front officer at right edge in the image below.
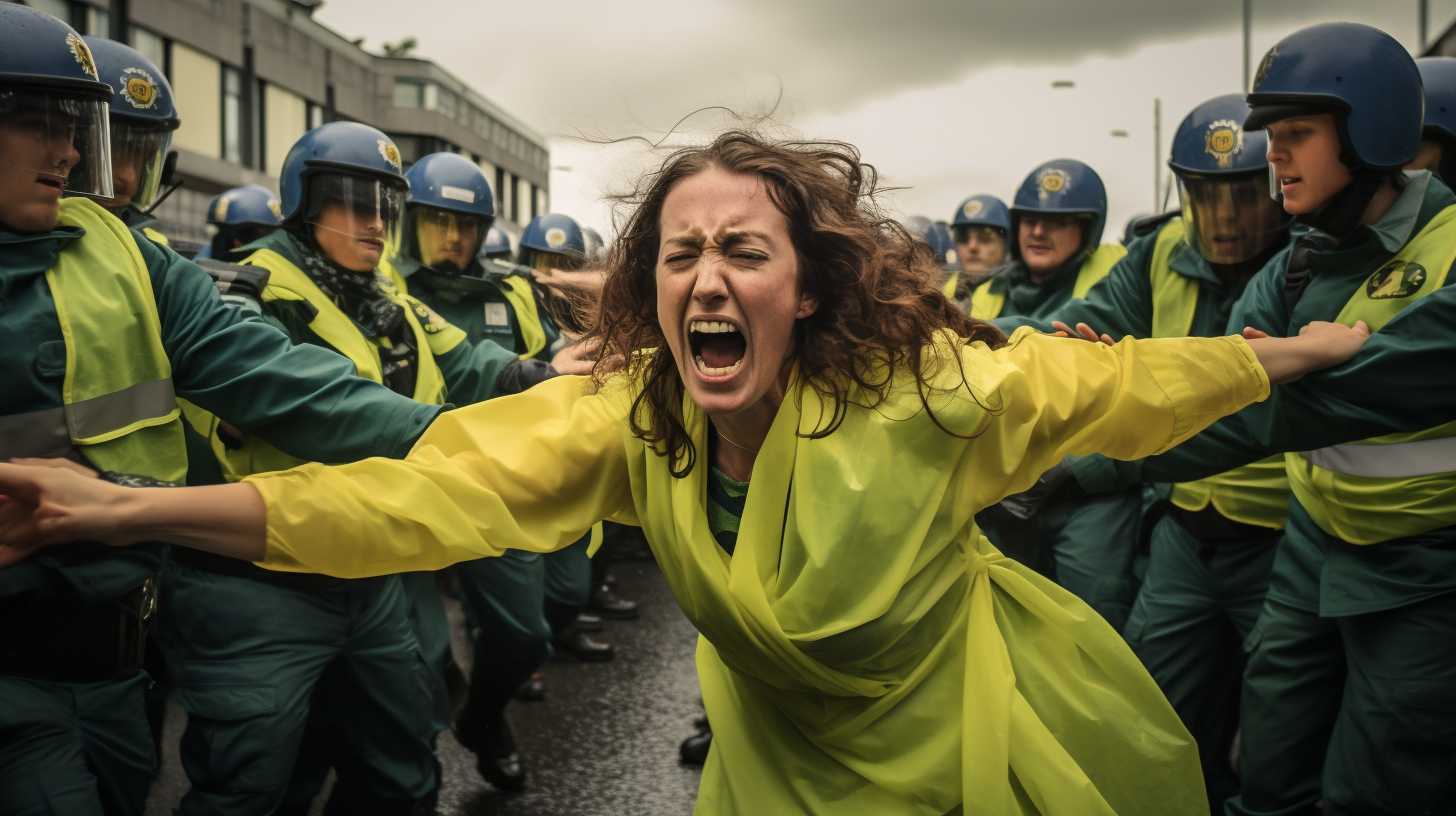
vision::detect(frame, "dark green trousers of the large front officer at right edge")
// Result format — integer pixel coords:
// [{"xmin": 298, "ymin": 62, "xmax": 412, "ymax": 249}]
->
[{"xmin": 1224, "ymin": 506, "xmax": 1456, "ymax": 816}]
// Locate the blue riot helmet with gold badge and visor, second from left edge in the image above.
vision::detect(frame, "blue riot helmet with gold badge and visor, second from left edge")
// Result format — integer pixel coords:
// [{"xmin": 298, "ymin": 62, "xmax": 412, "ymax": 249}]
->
[{"xmin": 84, "ymin": 36, "xmax": 182, "ymax": 210}]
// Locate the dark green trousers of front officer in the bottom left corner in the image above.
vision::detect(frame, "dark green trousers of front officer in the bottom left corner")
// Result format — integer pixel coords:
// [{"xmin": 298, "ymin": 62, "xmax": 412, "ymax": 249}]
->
[{"xmin": 0, "ymin": 672, "xmax": 156, "ymax": 816}]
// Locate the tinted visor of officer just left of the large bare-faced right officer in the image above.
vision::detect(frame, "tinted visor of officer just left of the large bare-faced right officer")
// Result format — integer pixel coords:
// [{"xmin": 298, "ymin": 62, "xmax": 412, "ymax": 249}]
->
[{"xmin": 1178, "ymin": 173, "xmax": 1286, "ymax": 264}]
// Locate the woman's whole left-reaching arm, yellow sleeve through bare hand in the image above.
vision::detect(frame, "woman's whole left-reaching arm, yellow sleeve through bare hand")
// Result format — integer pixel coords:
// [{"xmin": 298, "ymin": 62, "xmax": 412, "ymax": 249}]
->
[{"xmin": 0, "ymin": 377, "xmax": 632, "ymax": 577}]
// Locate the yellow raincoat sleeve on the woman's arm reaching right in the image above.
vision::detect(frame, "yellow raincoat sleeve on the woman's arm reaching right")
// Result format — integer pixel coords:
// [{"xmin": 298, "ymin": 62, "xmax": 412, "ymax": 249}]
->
[{"xmin": 962, "ymin": 328, "xmax": 1270, "ymax": 506}]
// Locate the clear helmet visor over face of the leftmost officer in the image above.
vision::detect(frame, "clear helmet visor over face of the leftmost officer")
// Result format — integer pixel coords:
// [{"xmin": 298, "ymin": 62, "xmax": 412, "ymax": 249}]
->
[{"xmin": 0, "ymin": 90, "xmax": 112, "ymax": 198}]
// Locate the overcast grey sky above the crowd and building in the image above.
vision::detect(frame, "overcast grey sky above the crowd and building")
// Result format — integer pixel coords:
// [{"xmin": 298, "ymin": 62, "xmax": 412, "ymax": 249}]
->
[{"xmin": 317, "ymin": 0, "xmax": 1456, "ymax": 240}]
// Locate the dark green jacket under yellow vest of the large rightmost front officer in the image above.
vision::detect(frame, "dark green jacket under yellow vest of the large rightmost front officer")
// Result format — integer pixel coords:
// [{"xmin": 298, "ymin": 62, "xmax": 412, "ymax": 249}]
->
[{"xmin": 1080, "ymin": 172, "xmax": 1456, "ymax": 615}]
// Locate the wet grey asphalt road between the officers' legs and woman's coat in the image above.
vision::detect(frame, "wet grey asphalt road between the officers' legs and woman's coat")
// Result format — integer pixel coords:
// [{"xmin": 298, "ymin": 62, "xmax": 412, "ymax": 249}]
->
[{"xmin": 147, "ymin": 550, "xmax": 702, "ymax": 816}]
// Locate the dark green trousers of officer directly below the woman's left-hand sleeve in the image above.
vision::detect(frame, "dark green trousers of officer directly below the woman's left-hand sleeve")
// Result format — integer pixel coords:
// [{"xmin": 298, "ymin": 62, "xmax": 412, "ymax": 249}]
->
[{"xmin": 162, "ymin": 564, "xmax": 440, "ymax": 815}]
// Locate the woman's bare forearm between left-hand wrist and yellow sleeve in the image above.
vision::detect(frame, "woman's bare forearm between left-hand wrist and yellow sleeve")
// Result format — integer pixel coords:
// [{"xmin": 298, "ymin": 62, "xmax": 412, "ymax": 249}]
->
[{"xmin": 116, "ymin": 482, "xmax": 268, "ymax": 561}]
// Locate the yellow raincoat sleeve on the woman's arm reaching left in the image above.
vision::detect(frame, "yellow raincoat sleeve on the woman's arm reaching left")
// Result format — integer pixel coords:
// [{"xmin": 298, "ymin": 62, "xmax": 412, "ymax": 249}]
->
[{"xmin": 248, "ymin": 377, "xmax": 635, "ymax": 578}]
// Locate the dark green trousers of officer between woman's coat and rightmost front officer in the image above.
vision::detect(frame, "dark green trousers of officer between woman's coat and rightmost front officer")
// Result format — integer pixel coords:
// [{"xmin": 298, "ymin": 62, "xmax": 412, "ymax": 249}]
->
[{"xmin": 1124, "ymin": 514, "xmax": 1280, "ymax": 812}]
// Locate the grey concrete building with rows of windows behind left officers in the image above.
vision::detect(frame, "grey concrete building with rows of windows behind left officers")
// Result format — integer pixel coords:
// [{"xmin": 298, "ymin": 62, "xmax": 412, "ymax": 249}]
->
[{"xmin": 12, "ymin": 0, "xmax": 550, "ymax": 240}]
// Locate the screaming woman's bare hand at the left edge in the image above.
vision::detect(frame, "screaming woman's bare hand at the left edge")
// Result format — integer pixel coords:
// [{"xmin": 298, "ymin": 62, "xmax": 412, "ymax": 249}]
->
[{"xmin": 0, "ymin": 459, "xmax": 131, "ymax": 567}]
